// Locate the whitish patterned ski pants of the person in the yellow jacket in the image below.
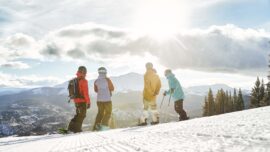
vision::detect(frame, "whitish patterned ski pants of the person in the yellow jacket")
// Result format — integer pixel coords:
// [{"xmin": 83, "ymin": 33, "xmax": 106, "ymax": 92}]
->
[{"xmin": 140, "ymin": 99, "xmax": 159, "ymax": 123}]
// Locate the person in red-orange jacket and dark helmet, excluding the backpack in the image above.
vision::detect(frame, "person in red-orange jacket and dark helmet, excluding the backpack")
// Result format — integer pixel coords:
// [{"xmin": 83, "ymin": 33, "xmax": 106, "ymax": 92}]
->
[{"xmin": 68, "ymin": 66, "xmax": 91, "ymax": 133}]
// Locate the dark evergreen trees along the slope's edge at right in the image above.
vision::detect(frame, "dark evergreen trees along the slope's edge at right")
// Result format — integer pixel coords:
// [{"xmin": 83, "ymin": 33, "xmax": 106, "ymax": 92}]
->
[{"xmin": 203, "ymin": 77, "xmax": 270, "ymax": 116}]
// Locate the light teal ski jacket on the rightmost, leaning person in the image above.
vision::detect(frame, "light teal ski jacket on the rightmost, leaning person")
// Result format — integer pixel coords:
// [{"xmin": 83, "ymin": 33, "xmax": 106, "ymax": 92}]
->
[{"xmin": 165, "ymin": 73, "xmax": 185, "ymax": 101}]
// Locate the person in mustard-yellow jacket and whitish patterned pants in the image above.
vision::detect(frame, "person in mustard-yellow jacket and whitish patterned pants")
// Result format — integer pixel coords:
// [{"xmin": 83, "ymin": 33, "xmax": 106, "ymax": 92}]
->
[{"xmin": 139, "ymin": 62, "xmax": 161, "ymax": 126}]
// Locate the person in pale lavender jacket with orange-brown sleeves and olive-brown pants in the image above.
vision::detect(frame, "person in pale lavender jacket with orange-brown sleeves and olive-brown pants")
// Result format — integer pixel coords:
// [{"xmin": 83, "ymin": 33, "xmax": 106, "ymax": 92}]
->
[{"xmin": 93, "ymin": 67, "xmax": 114, "ymax": 131}]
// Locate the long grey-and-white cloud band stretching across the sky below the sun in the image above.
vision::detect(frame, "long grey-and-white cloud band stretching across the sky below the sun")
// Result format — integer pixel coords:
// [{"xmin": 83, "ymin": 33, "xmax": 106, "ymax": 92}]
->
[{"xmin": 0, "ymin": 23, "xmax": 270, "ymax": 74}]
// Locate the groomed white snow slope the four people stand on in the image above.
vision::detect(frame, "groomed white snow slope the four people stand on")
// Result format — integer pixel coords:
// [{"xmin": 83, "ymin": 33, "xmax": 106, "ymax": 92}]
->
[{"xmin": 0, "ymin": 107, "xmax": 270, "ymax": 152}]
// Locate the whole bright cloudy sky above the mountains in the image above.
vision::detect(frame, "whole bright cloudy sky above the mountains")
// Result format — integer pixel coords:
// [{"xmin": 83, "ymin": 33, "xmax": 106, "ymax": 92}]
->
[{"xmin": 0, "ymin": 0, "xmax": 270, "ymax": 90}]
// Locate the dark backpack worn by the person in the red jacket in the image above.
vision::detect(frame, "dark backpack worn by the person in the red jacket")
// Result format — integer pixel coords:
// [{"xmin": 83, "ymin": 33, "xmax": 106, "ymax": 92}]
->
[{"xmin": 68, "ymin": 78, "xmax": 84, "ymax": 102}]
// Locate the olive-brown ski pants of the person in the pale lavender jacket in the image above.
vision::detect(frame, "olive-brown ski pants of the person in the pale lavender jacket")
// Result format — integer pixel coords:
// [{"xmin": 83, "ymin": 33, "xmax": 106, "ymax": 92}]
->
[{"xmin": 93, "ymin": 101, "xmax": 112, "ymax": 130}]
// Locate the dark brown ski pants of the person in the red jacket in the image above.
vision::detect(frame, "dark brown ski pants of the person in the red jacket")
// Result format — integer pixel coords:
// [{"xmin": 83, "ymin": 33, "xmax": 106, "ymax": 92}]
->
[{"xmin": 68, "ymin": 102, "xmax": 87, "ymax": 133}]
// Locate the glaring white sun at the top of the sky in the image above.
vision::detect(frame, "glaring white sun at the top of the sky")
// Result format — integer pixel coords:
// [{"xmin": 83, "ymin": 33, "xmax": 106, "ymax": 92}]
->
[{"xmin": 132, "ymin": 0, "xmax": 189, "ymax": 39}]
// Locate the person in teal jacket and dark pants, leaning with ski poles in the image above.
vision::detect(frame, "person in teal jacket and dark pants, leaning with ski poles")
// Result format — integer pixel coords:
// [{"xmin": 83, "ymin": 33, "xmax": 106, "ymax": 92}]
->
[{"xmin": 163, "ymin": 69, "xmax": 188, "ymax": 121}]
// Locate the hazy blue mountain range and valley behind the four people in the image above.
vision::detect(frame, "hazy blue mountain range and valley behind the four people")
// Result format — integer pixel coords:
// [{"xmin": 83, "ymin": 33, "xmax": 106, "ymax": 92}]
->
[{"xmin": 0, "ymin": 73, "xmax": 251, "ymax": 137}]
